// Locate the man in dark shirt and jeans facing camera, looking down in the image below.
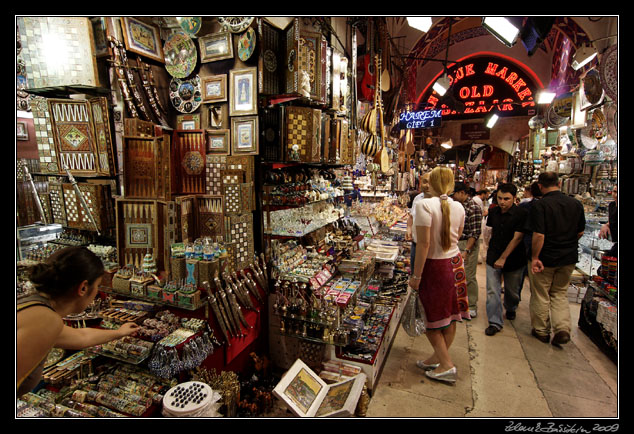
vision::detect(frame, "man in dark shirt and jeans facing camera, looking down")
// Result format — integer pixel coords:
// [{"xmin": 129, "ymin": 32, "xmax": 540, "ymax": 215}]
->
[{"xmin": 485, "ymin": 184, "xmax": 527, "ymax": 336}]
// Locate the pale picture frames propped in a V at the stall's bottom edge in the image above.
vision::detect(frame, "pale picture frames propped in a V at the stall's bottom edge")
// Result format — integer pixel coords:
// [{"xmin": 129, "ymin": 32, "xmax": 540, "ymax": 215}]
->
[{"xmin": 273, "ymin": 359, "xmax": 366, "ymax": 417}]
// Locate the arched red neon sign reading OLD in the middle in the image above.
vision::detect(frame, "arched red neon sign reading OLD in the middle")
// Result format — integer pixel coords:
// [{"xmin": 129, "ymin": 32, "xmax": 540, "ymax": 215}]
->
[{"xmin": 418, "ymin": 54, "xmax": 543, "ymax": 119}]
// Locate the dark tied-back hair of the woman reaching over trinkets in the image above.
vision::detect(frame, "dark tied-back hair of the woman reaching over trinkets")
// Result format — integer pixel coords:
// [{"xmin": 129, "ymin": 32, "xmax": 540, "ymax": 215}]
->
[{"xmin": 29, "ymin": 247, "xmax": 104, "ymax": 298}]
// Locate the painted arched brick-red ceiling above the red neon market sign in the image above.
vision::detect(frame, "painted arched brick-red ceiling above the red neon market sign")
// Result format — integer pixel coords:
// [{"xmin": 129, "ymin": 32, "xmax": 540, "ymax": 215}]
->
[{"xmin": 386, "ymin": 16, "xmax": 618, "ymax": 106}]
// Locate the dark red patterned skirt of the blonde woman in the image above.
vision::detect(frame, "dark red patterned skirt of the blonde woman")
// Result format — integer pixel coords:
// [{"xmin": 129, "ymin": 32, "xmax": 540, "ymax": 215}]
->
[{"xmin": 418, "ymin": 254, "xmax": 471, "ymax": 329}]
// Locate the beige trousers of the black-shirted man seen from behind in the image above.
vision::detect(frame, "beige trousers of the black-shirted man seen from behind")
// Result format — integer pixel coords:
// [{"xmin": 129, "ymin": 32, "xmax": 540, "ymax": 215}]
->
[{"xmin": 528, "ymin": 262, "xmax": 575, "ymax": 336}]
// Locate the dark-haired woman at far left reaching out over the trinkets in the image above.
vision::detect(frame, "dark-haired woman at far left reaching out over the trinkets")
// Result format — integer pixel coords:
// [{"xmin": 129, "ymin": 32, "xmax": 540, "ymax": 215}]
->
[{"xmin": 16, "ymin": 247, "xmax": 138, "ymax": 396}]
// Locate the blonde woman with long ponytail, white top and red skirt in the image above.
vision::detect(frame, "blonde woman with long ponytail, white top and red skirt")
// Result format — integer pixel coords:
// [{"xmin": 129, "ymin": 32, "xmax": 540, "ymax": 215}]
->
[{"xmin": 409, "ymin": 167, "xmax": 470, "ymax": 384}]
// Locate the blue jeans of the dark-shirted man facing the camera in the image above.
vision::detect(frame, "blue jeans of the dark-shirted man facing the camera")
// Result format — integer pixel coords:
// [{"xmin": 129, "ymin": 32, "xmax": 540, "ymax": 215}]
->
[{"xmin": 487, "ymin": 265, "xmax": 525, "ymax": 329}]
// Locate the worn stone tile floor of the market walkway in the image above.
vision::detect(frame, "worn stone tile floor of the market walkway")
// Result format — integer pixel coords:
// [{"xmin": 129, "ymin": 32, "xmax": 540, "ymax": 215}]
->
[{"xmin": 366, "ymin": 265, "xmax": 619, "ymax": 422}]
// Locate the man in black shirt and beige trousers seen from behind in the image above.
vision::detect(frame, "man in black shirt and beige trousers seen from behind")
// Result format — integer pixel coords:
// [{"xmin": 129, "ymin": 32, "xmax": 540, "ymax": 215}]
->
[{"xmin": 528, "ymin": 172, "xmax": 586, "ymax": 345}]
